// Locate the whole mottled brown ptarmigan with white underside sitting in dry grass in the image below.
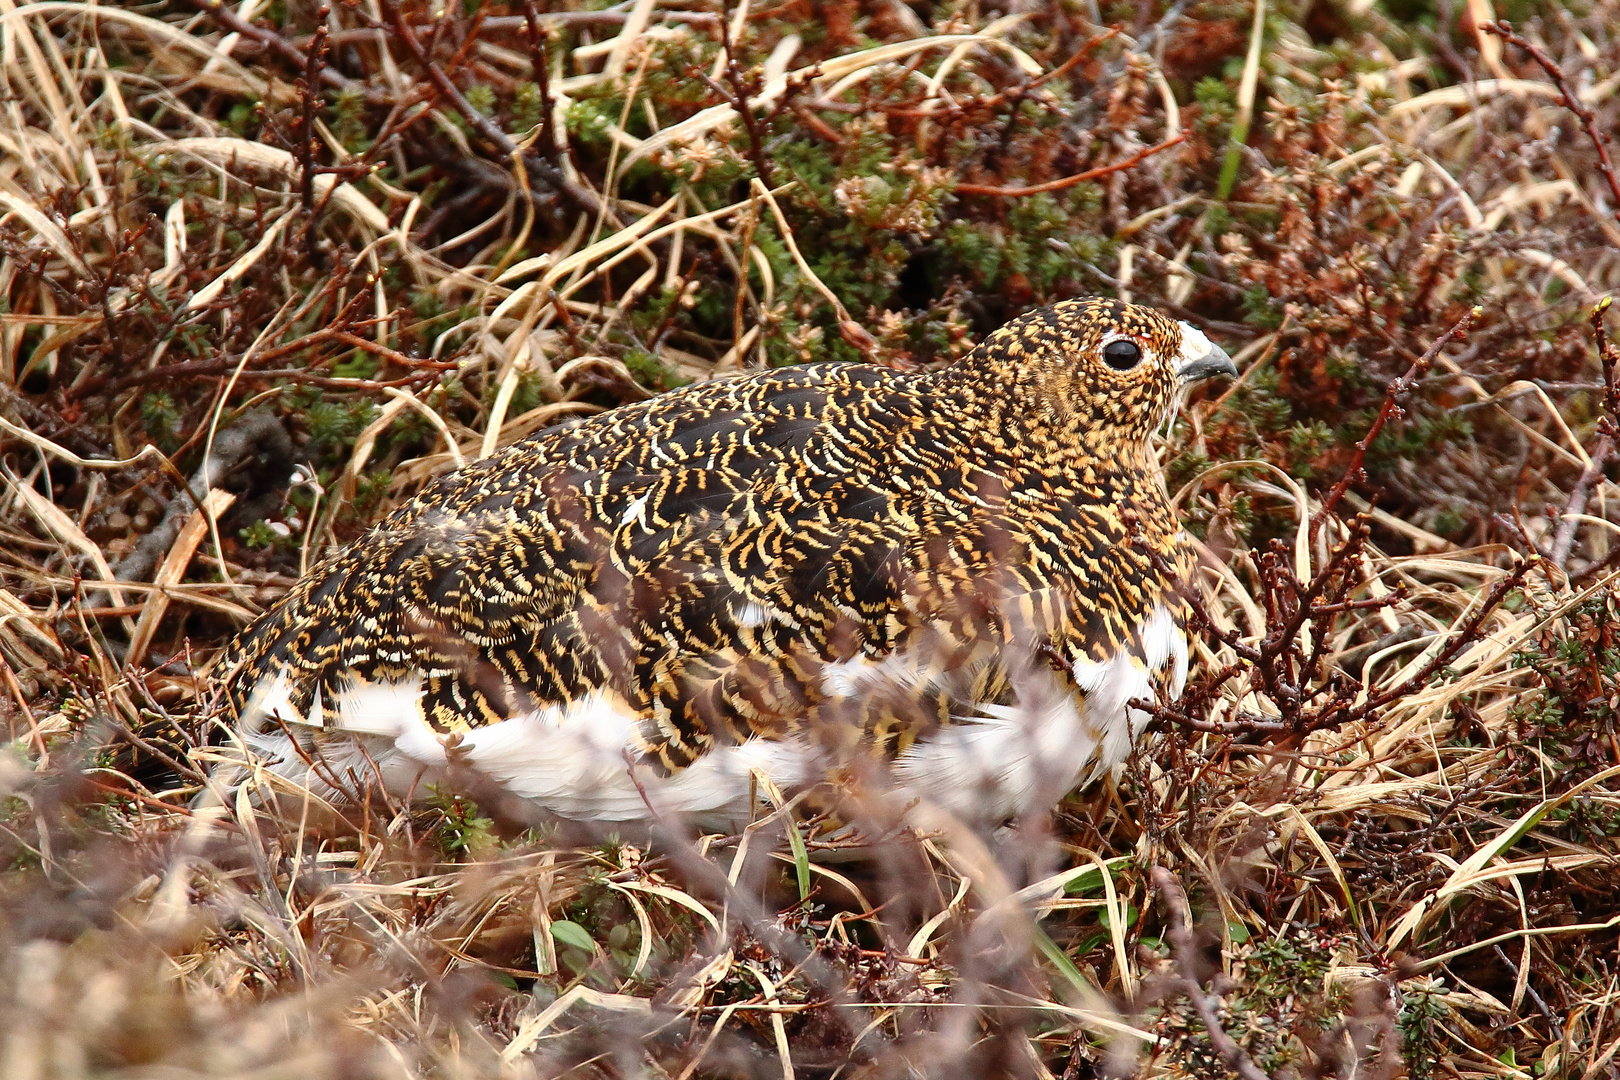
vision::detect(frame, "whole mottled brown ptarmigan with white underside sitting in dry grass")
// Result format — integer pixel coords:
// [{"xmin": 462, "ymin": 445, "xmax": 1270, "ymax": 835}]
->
[{"xmin": 212, "ymin": 300, "xmax": 1234, "ymax": 823}]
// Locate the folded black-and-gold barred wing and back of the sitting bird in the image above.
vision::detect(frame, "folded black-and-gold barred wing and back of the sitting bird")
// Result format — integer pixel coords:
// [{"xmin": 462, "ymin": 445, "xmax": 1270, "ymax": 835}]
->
[{"xmin": 227, "ymin": 366, "xmax": 946, "ymax": 744}]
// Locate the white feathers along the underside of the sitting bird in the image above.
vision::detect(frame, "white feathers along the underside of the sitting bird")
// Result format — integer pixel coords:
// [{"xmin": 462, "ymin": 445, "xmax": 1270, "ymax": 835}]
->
[{"xmin": 243, "ymin": 607, "xmax": 1187, "ymax": 823}]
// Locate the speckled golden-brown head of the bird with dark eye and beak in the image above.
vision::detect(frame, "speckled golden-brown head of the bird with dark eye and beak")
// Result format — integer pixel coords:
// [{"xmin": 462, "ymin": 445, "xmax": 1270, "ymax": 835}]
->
[{"xmin": 969, "ymin": 296, "xmax": 1238, "ymax": 450}]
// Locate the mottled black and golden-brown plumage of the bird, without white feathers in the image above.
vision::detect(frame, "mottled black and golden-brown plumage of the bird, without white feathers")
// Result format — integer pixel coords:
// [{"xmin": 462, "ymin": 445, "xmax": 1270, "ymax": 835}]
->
[{"xmin": 225, "ymin": 300, "xmax": 1189, "ymax": 772}]
